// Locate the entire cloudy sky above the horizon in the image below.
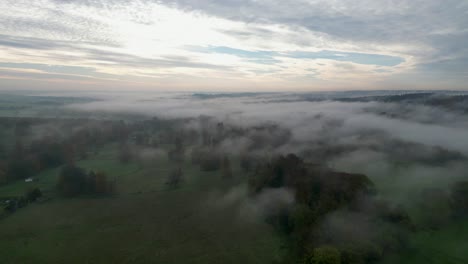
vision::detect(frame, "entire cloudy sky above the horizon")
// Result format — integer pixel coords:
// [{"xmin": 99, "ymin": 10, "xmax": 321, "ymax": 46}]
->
[{"xmin": 0, "ymin": 0, "xmax": 468, "ymax": 92}]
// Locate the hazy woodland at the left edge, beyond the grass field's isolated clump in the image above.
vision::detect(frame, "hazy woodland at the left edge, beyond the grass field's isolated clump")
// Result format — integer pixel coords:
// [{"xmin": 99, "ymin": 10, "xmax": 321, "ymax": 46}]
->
[{"xmin": 0, "ymin": 118, "xmax": 129, "ymax": 184}]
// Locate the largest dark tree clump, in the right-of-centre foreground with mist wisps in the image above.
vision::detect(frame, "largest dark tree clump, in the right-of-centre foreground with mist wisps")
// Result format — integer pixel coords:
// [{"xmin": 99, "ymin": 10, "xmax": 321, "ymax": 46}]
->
[{"xmin": 249, "ymin": 154, "xmax": 413, "ymax": 264}]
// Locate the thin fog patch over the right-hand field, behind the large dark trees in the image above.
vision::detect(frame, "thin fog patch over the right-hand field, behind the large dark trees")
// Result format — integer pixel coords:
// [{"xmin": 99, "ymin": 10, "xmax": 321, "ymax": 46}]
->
[{"xmin": 330, "ymin": 150, "xmax": 468, "ymax": 204}]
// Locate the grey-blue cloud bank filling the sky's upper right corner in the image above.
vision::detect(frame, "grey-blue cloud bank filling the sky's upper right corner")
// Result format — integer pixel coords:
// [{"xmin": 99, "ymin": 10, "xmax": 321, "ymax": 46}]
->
[{"xmin": 158, "ymin": 0, "xmax": 468, "ymax": 79}]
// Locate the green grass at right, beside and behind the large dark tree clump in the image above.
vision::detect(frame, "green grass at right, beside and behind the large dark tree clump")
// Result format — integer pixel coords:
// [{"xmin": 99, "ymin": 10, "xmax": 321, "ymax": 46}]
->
[{"xmin": 336, "ymin": 164, "xmax": 468, "ymax": 264}]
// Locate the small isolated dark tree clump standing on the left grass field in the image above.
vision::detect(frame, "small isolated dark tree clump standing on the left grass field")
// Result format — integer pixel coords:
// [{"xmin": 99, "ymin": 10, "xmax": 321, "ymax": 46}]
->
[{"xmin": 57, "ymin": 164, "xmax": 115, "ymax": 197}]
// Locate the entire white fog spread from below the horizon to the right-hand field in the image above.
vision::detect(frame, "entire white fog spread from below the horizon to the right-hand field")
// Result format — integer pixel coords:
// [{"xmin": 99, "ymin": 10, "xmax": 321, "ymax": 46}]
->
[{"xmin": 67, "ymin": 92, "xmax": 468, "ymax": 208}]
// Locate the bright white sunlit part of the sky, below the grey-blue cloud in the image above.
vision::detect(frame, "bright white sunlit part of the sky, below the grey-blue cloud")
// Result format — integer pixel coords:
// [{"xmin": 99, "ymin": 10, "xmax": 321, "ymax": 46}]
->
[{"xmin": 0, "ymin": 0, "xmax": 466, "ymax": 90}]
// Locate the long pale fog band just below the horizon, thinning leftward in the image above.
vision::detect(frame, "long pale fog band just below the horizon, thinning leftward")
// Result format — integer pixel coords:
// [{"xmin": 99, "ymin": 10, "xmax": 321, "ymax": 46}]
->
[{"xmin": 67, "ymin": 94, "xmax": 468, "ymax": 154}]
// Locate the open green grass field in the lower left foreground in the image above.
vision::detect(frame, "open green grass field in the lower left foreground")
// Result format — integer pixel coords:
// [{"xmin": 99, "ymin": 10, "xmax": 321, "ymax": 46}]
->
[{"xmin": 0, "ymin": 145, "xmax": 281, "ymax": 264}]
